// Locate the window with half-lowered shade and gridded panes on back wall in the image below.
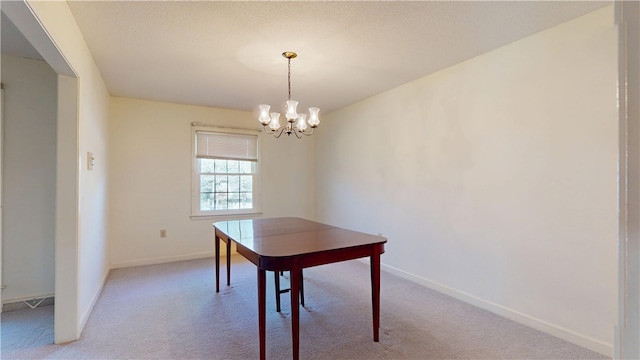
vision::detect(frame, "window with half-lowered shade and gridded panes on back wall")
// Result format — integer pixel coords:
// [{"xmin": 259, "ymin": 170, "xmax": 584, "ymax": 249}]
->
[{"xmin": 192, "ymin": 130, "xmax": 259, "ymax": 216}]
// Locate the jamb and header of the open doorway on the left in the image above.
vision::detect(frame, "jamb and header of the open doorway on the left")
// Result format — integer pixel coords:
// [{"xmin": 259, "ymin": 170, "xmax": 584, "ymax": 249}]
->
[{"xmin": 1, "ymin": 1, "xmax": 81, "ymax": 344}]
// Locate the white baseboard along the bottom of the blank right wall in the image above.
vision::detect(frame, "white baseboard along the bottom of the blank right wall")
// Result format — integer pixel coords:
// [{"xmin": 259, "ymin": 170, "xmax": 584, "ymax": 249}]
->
[{"xmin": 381, "ymin": 264, "xmax": 613, "ymax": 357}]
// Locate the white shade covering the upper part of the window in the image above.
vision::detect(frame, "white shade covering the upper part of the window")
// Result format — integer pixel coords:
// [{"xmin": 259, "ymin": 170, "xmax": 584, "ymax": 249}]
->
[{"xmin": 196, "ymin": 131, "xmax": 258, "ymax": 161}]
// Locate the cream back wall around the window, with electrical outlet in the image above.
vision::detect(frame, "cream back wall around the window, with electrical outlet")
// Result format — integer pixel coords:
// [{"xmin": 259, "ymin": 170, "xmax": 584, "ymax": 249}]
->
[{"xmin": 109, "ymin": 97, "xmax": 314, "ymax": 267}]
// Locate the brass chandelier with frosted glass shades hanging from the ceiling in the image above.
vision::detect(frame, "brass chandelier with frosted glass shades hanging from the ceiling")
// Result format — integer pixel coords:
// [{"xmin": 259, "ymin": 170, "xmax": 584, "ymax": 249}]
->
[{"xmin": 258, "ymin": 51, "xmax": 320, "ymax": 139}]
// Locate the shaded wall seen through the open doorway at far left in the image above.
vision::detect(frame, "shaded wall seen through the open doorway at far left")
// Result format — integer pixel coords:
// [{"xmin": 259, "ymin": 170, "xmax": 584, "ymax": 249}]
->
[{"xmin": 2, "ymin": 55, "xmax": 57, "ymax": 304}]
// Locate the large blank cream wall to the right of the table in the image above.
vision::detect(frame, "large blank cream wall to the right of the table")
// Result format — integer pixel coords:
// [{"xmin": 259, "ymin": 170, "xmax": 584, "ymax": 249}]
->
[{"xmin": 316, "ymin": 7, "xmax": 618, "ymax": 355}]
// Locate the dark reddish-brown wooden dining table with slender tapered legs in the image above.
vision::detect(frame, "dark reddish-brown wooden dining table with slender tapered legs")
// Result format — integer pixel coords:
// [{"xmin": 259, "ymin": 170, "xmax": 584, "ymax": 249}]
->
[{"xmin": 213, "ymin": 217, "xmax": 387, "ymax": 360}]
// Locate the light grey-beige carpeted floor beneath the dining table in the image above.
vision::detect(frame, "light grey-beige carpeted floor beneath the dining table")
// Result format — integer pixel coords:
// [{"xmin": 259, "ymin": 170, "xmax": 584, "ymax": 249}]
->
[{"xmin": 0, "ymin": 256, "xmax": 606, "ymax": 359}]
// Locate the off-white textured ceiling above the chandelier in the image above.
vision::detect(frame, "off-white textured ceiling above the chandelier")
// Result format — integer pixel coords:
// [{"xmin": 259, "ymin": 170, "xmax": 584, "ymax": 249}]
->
[{"xmin": 55, "ymin": 1, "xmax": 610, "ymax": 115}]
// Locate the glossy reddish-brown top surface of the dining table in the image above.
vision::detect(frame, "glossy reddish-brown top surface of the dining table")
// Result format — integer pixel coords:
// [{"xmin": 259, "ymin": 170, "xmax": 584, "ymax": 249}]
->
[{"xmin": 213, "ymin": 217, "xmax": 387, "ymax": 257}]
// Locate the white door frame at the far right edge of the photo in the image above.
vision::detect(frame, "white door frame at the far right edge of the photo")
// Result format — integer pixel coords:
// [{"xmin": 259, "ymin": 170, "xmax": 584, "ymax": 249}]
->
[{"xmin": 613, "ymin": 0, "xmax": 640, "ymax": 359}]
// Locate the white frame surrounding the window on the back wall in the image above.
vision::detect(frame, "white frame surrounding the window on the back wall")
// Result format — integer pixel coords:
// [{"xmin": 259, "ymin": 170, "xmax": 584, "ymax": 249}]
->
[{"xmin": 191, "ymin": 126, "xmax": 262, "ymax": 219}]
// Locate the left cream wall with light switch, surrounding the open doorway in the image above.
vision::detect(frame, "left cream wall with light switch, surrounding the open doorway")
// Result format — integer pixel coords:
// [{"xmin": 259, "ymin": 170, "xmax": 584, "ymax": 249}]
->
[{"xmin": 20, "ymin": 1, "xmax": 109, "ymax": 343}]
